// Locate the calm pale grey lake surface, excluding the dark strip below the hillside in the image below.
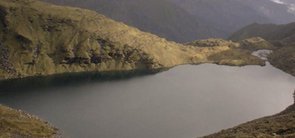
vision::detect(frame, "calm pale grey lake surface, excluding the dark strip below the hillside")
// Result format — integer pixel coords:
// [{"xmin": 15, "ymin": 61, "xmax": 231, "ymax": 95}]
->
[{"xmin": 0, "ymin": 64, "xmax": 295, "ymax": 138}]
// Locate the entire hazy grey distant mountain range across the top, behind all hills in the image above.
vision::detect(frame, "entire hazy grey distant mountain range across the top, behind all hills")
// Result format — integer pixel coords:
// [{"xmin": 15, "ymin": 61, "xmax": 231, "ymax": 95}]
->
[{"xmin": 44, "ymin": 0, "xmax": 295, "ymax": 42}]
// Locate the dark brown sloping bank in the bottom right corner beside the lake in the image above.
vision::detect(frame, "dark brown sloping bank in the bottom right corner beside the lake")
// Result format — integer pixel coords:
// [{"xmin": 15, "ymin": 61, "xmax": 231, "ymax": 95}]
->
[{"xmin": 204, "ymin": 92, "xmax": 295, "ymax": 138}]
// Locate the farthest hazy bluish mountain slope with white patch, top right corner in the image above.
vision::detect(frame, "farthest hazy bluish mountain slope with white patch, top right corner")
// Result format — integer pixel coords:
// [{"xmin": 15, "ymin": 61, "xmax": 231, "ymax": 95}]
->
[{"xmin": 172, "ymin": 0, "xmax": 295, "ymax": 37}]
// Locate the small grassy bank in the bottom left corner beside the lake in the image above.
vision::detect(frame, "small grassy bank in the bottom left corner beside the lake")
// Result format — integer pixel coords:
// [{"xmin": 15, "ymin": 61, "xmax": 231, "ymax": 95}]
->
[{"xmin": 0, "ymin": 105, "xmax": 57, "ymax": 138}]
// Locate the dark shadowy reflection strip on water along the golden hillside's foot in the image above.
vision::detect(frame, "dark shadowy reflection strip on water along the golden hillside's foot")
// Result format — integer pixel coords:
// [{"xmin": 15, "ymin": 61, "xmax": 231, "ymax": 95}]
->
[{"xmin": 0, "ymin": 69, "xmax": 165, "ymax": 94}]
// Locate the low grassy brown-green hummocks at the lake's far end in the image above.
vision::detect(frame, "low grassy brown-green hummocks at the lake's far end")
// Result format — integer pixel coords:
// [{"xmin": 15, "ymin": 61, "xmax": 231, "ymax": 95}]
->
[{"xmin": 187, "ymin": 38, "xmax": 272, "ymax": 66}]
